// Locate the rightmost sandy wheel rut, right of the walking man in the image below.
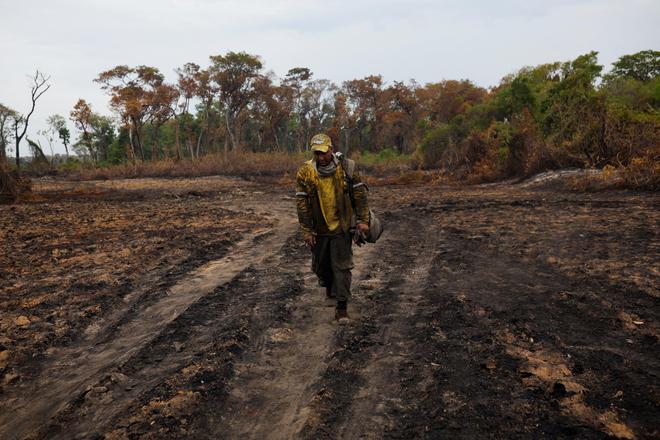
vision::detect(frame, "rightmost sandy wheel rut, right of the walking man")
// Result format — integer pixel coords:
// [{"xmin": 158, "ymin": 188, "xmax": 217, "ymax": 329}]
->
[{"xmin": 337, "ymin": 220, "xmax": 437, "ymax": 439}]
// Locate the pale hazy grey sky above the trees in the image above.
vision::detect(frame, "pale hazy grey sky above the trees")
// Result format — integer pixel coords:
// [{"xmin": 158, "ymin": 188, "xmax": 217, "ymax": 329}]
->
[{"xmin": 0, "ymin": 0, "xmax": 660, "ymax": 152}]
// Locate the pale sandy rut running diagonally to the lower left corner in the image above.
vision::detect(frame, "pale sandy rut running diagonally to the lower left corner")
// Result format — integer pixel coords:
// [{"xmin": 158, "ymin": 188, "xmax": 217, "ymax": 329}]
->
[{"xmin": 0, "ymin": 207, "xmax": 295, "ymax": 439}]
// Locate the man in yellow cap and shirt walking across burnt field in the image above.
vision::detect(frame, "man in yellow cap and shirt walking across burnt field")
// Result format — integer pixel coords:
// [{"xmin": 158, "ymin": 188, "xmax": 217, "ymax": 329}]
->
[{"xmin": 296, "ymin": 134, "xmax": 369, "ymax": 322}]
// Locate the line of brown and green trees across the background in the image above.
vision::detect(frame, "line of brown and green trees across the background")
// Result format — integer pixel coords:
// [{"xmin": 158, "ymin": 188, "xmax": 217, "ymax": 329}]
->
[{"xmin": 0, "ymin": 50, "xmax": 660, "ymax": 177}]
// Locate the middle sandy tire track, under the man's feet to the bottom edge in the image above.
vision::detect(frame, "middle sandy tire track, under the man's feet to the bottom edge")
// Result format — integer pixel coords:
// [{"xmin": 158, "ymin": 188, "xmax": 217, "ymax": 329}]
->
[{"xmin": 213, "ymin": 227, "xmax": 390, "ymax": 439}]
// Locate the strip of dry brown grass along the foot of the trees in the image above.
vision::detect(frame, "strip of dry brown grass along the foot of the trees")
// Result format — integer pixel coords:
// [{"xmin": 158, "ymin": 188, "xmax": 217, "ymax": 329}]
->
[{"xmin": 51, "ymin": 152, "xmax": 660, "ymax": 192}]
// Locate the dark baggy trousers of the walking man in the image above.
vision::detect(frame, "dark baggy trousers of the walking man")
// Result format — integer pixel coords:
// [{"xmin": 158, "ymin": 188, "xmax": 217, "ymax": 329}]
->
[{"xmin": 312, "ymin": 232, "xmax": 353, "ymax": 301}]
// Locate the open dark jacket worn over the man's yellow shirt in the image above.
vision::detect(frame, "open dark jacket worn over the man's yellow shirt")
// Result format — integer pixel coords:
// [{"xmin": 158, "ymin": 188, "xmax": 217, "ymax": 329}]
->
[{"xmin": 296, "ymin": 158, "xmax": 369, "ymax": 236}]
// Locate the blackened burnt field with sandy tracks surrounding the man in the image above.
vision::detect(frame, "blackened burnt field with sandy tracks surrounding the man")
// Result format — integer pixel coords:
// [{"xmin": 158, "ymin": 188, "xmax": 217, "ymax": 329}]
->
[{"xmin": 0, "ymin": 178, "xmax": 660, "ymax": 439}]
